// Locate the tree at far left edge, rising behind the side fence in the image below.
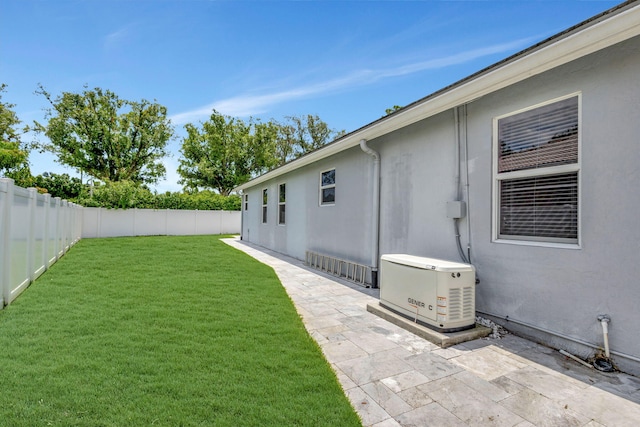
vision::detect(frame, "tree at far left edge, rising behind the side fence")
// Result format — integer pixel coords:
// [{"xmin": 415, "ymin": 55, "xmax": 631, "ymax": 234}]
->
[{"xmin": 0, "ymin": 83, "xmax": 31, "ymax": 180}]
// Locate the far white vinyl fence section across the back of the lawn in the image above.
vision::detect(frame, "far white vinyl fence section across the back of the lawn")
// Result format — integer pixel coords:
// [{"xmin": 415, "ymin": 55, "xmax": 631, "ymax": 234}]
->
[{"xmin": 82, "ymin": 208, "xmax": 241, "ymax": 238}]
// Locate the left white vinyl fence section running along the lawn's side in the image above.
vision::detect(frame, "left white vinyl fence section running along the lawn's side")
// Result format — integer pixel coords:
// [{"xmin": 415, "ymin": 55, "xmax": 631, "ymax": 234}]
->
[{"xmin": 0, "ymin": 178, "xmax": 82, "ymax": 309}]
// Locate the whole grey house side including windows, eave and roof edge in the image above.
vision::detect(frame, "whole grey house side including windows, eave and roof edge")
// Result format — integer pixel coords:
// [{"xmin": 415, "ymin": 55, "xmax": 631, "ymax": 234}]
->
[{"xmin": 238, "ymin": 2, "xmax": 640, "ymax": 374}]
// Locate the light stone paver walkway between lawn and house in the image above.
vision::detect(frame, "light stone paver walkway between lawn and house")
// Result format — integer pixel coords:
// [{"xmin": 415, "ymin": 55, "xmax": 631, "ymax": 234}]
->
[{"xmin": 225, "ymin": 239, "xmax": 640, "ymax": 427}]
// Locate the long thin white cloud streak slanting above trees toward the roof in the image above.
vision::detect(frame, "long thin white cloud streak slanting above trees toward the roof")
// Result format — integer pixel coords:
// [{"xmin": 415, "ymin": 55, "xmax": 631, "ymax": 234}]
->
[{"xmin": 170, "ymin": 38, "xmax": 534, "ymax": 125}]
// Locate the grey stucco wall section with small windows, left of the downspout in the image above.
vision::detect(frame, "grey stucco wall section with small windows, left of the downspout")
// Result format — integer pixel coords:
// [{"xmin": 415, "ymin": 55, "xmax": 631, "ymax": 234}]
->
[{"xmin": 242, "ymin": 148, "xmax": 372, "ymax": 270}]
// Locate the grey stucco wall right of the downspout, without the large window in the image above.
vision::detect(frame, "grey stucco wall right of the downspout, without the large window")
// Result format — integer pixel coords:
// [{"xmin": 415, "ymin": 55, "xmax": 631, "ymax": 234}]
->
[{"xmin": 370, "ymin": 38, "xmax": 640, "ymax": 372}]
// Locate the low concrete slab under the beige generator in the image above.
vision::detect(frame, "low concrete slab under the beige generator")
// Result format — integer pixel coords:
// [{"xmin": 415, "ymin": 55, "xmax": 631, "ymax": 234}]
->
[{"xmin": 367, "ymin": 303, "xmax": 491, "ymax": 348}]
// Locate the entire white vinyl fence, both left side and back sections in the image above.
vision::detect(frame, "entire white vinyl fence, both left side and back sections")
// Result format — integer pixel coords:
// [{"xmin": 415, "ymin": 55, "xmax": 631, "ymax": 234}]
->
[{"xmin": 0, "ymin": 178, "xmax": 241, "ymax": 309}]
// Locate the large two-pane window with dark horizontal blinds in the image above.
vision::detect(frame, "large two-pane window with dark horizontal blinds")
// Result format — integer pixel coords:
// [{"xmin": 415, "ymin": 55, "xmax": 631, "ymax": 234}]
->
[{"xmin": 494, "ymin": 95, "xmax": 580, "ymax": 244}]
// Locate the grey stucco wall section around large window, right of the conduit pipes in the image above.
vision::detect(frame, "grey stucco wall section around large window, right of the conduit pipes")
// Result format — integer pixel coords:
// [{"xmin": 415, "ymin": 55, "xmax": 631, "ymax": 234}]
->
[{"xmin": 468, "ymin": 37, "xmax": 640, "ymax": 372}]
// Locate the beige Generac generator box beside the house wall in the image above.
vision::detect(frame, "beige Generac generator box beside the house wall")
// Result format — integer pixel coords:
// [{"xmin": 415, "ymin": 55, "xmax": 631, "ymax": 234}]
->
[{"xmin": 380, "ymin": 254, "xmax": 476, "ymax": 332}]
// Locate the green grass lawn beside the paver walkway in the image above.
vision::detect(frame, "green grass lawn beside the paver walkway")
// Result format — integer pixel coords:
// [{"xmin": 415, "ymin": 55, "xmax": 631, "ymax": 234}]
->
[{"xmin": 0, "ymin": 236, "xmax": 360, "ymax": 426}]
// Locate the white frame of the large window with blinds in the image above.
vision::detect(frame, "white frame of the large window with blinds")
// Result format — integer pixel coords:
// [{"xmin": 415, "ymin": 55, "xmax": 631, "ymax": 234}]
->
[{"xmin": 492, "ymin": 92, "xmax": 583, "ymax": 249}]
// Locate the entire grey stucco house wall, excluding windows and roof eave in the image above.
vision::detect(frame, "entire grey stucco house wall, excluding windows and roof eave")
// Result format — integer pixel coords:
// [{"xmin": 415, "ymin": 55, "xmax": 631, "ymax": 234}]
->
[{"xmin": 243, "ymin": 37, "xmax": 640, "ymax": 374}]
